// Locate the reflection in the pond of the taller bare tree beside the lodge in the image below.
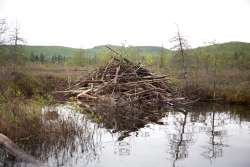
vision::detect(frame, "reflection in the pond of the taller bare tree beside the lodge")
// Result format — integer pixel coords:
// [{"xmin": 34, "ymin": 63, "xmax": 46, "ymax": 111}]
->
[{"xmin": 169, "ymin": 112, "xmax": 193, "ymax": 166}]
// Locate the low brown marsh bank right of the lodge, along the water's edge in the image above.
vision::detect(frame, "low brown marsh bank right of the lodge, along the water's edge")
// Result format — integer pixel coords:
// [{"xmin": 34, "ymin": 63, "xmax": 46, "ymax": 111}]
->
[{"xmin": 178, "ymin": 69, "xmax": 250, "ymax": 104}]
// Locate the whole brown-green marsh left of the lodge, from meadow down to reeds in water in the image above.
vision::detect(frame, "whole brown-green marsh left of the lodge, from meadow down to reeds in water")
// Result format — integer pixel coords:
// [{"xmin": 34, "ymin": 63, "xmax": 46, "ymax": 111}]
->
[{"xmin": 0, "ymin": 64, "xmax": 97, "ymax": 160}]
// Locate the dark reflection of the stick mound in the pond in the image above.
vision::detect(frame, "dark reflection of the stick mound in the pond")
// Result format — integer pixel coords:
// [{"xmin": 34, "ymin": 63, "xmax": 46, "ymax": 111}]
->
[{"xmin": 83, "ymin": 104, "xmax": 166, "ymax": 141}]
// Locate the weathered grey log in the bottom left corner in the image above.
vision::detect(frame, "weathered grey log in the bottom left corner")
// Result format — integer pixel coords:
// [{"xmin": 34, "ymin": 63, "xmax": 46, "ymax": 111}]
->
[{"xmin": 0, "ymin": 133, "xmax": 44, "ymax": 167}]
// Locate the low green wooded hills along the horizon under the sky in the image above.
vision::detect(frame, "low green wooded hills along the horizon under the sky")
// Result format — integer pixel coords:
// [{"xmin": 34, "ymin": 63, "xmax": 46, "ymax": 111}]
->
[{"xmin": 1, "ymin": 42, "xmax": 250, "ymax": 67}]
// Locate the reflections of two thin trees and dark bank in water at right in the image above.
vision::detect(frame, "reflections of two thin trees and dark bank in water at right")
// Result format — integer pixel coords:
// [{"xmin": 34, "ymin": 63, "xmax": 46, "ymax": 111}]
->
[{"xmin": 163, "ymin": 104, "xmax": 250, "ymax": 166}]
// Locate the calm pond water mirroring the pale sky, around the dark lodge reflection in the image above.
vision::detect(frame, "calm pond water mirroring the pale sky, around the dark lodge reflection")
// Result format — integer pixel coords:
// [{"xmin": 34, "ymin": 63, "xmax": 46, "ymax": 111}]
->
[{"xmin": 0, "ymin": 104, "xmax": 250, "ymax": 167}]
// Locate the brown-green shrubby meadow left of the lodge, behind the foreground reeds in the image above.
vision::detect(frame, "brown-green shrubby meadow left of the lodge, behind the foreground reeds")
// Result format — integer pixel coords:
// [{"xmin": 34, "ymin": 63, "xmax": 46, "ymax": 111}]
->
[{"xmin": 0, "ymin": 64, "xmax": 88, "ymax": 103}]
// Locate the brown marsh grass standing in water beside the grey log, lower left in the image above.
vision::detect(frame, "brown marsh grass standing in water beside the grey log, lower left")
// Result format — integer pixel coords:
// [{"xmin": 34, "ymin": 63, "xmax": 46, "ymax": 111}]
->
[{"xmin": 0, "ymin": 100, "xmax": 100, "ymax": 164}]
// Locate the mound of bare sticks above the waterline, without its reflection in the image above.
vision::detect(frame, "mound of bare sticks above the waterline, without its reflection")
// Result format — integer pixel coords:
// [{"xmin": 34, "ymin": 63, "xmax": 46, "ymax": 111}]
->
[{"xmin": 60, "ymin": 57, "xmax": 188, "ymax": 107}]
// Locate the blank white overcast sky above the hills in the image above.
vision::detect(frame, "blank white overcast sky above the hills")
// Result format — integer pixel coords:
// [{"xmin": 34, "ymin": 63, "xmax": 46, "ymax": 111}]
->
[{"xmin": 0, "ymin": 0, "xmax": 250, "ymax": 48}]
